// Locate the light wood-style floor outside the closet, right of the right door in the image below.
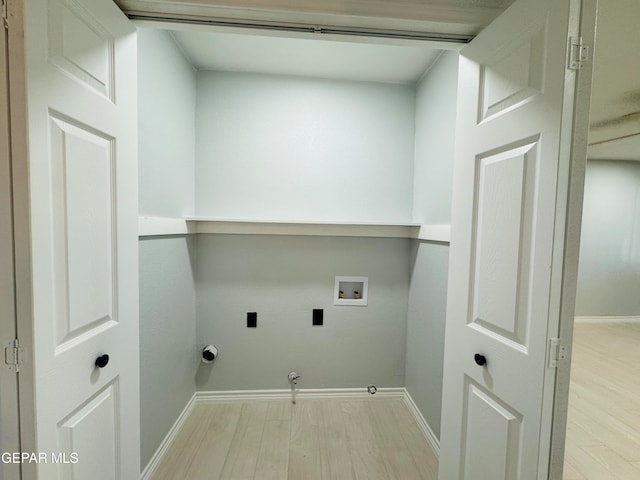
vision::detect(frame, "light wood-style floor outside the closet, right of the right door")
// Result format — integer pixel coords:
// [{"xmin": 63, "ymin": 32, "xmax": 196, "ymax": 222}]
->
[{"xmin": 564, "ymin": 323, "xmax": 640, "ymax": 480}]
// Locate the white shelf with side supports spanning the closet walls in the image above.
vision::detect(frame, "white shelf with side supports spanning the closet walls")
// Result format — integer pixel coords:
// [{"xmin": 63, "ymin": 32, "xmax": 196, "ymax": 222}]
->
[{"xmin": 138, "ymin": 217, "xmax": 449, "ymax": 243}]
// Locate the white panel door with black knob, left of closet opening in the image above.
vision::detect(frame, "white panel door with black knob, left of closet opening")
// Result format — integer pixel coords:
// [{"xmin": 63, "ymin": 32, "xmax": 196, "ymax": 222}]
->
[{"xmin": 25, "ymin": 0, "xmax": 140, "ymax": 480}]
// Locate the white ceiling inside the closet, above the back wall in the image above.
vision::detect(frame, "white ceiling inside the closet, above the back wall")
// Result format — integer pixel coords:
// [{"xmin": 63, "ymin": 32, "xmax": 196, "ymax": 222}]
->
[{"xmin": 172, "ymin": 30, "xmax": 440, "ymax": 83}]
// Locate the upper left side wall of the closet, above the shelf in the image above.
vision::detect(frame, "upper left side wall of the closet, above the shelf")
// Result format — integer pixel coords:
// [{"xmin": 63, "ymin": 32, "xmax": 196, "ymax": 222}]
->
[{"xmin": 138, "ymin": 28, "xmax": 196, "ymax": 218}]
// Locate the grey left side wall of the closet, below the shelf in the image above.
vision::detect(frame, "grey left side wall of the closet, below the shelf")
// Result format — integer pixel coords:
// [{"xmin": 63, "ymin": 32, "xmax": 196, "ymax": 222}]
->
[{"xmin": 140, "ymin": 237, "xmax": 200, "ymax": 468}]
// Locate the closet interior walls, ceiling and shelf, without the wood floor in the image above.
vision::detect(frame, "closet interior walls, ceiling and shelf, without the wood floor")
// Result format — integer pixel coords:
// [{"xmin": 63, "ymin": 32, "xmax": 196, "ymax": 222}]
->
[{"xmin": 138, "ymin": 23, "xmax": 459, "ymax": 469}]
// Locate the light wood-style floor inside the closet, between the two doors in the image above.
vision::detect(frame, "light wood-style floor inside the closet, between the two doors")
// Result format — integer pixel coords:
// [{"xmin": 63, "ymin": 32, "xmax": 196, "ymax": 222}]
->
[{"xmin": 153, "ymin": 397, "xmax": 438, "ymax": 480}]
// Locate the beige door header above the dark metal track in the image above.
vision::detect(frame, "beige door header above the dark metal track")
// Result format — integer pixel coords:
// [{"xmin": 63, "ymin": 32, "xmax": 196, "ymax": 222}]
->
[{"xmin": 115, "ymin": 0, "xmax": 513, "ymax": 36}]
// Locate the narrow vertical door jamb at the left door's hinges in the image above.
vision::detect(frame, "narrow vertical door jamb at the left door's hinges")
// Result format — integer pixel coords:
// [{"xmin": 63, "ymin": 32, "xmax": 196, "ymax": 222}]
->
[{"xmin": 6, "ymin": 0, "xmax": 37, "ymax": 479}]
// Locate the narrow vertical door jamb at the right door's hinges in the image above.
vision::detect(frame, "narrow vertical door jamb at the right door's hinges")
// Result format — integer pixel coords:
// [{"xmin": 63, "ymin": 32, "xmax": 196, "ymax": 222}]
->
[{"xmin": 549, "ymin": 0, "xmax": 598, "ymax": 480}]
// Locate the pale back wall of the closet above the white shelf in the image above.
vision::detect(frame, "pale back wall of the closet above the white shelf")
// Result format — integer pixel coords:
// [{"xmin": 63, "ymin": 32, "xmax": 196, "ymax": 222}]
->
[{"xmin": 196, "ymin": 72, "xmax": 415, "ymax": 222}]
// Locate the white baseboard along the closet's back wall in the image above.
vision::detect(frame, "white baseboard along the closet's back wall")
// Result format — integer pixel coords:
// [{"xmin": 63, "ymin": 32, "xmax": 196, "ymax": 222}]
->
[{"xmin": 195, "ymin": 387, "xmax": 405, "ymax": 403}]
